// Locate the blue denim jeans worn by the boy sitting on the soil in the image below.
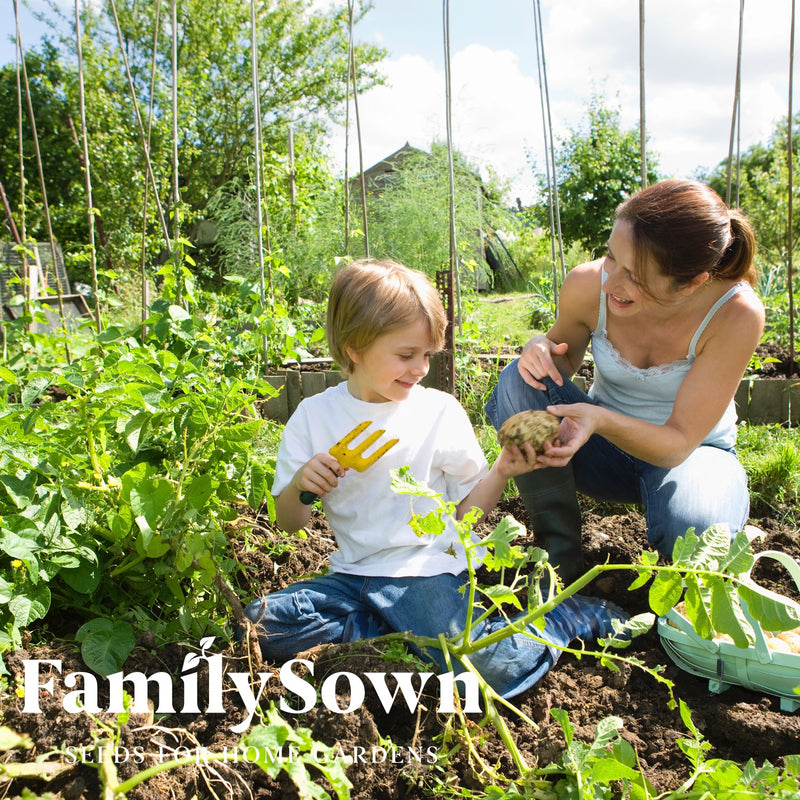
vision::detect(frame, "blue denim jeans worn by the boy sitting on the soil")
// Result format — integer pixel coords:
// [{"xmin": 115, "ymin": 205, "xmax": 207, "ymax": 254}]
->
[{"xmin": 245, "ymin": 573, "xmax": 626, "ymax": 697}]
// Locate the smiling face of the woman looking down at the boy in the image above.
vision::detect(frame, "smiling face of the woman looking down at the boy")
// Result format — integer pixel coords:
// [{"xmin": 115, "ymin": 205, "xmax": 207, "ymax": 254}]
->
[{"xmin": 603, "ymin": 220, "xmax": 676, "ymax": 316}]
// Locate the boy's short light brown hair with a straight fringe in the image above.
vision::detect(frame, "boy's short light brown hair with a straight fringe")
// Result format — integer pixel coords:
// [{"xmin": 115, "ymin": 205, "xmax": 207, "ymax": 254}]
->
[{"xmin": 325, "ymin": 259, "xmax": 447, "ymax": 374}]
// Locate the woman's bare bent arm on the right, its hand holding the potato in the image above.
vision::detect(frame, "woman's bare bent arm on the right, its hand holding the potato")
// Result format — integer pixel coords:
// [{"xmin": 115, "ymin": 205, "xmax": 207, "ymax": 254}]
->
[{"xmin": 538, "ymin": 292, "xmax": 764, "ymax": 468}]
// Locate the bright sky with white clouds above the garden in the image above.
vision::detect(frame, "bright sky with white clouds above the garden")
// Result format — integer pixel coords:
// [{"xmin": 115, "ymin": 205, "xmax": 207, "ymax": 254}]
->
[{"xmin": 6, "ymin": 0, "xmax": 800, "ymax": 203}]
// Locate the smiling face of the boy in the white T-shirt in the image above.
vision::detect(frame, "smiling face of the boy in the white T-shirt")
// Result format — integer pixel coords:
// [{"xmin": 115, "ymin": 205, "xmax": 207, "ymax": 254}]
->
[{"xmin": 348, "ymin": 319, "xmax": 433, "ymax": 403}]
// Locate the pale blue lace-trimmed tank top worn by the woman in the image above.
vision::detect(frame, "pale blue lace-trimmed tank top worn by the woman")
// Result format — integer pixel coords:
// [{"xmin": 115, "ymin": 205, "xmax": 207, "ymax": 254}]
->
[{"xmin": 589, "ymin": 272, "xmax": 752, "ymax": 449}]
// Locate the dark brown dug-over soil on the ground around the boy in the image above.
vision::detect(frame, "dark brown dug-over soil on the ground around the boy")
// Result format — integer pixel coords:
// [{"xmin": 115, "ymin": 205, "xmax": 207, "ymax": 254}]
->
[{"xmin": 0, "ymin": 499, "xmax": 800, "ymax": 800}]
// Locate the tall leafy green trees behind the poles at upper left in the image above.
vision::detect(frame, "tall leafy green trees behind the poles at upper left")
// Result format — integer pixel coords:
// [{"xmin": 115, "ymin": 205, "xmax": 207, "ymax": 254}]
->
[{"xmin": 0, "ymin": 0, "xmax": 382, "ymax": 292}]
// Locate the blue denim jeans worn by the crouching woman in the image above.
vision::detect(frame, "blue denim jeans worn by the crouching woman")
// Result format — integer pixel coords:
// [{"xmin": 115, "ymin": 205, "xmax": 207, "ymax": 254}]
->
[{"xmin": 486, "ymin": 361, "xmax": 750, "ymax": 558}]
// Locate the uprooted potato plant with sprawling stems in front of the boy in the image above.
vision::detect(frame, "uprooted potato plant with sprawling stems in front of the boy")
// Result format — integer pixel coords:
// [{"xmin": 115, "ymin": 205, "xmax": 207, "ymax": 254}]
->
[{"xmin": 385, "ymin": 468, "xmax": 800, "ymax": 800}]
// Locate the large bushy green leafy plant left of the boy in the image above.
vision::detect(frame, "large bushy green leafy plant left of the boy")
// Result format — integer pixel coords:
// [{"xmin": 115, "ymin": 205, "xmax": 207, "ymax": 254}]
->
[{"xmin": 0, "ymin": 307, "xmax": 274, "ymax": 674}]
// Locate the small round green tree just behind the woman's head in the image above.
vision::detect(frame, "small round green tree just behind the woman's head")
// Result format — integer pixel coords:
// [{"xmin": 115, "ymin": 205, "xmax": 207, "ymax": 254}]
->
[{"xmin": 535, "ymin": 95, "xmax": 658, "ymax": 251}]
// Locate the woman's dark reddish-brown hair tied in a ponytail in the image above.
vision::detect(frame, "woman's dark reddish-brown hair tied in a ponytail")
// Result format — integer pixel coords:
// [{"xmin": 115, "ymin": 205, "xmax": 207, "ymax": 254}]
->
[{"xmin": 616, "ymin": 179, "xmax": 757, "ymax": 289}]
